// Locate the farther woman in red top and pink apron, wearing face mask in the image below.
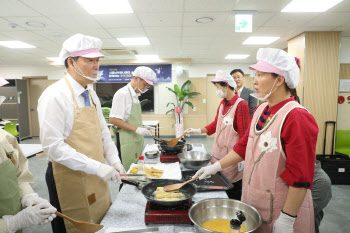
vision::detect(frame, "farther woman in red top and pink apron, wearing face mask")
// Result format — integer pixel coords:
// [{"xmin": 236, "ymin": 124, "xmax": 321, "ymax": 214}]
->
[{"xmin": 188, "ymin": 70, "xmax": 250, "ymax": 200}]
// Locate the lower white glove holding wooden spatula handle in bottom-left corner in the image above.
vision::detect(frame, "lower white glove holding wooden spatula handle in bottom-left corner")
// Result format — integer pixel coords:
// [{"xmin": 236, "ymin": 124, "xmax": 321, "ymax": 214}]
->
[{"xmin": 3, "ymin": 202, "xmax": 57, "ymax": 233}]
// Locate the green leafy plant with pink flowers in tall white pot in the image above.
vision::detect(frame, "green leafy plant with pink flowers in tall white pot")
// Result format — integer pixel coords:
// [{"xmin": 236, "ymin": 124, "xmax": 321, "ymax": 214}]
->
[{"xmin": 166, "ymin": 80, "xmax": 200, "ymax": 137}]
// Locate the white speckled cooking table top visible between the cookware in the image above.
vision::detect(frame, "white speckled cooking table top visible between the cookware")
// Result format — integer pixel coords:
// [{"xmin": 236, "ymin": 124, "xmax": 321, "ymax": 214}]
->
[{"xmin": 98, "ymin": 144, "xmax": 228, "ymax": 233}]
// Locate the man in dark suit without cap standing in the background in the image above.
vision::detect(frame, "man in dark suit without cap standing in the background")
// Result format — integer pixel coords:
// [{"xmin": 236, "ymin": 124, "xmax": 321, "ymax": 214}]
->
[{"xmin": 230, "ymin": 69, "xmax": 258, "ymax": 117}]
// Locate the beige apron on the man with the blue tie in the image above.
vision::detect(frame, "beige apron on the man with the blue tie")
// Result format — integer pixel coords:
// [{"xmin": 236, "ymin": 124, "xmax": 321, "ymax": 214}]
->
[{"xmin": 52, "ymin": 78, "xmax": 111, "ymax": 233}]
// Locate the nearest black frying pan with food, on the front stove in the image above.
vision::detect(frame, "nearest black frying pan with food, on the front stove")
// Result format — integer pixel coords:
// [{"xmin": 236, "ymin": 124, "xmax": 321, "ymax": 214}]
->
[{"xmin": 122, "ymin": 180, "xmax": 197, "ymax": 206}]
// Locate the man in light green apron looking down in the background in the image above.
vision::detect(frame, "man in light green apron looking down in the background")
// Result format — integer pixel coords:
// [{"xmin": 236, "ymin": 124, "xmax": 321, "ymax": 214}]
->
[{"xmin": 109, "ymin": 66, "xmax": 157, "ymax": 170}]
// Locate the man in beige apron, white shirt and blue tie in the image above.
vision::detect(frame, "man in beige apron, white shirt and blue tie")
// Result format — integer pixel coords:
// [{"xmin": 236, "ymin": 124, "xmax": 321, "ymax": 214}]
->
[{"xmin": 38, "ymin": 34, "xmax": 125, "ymax": 233}]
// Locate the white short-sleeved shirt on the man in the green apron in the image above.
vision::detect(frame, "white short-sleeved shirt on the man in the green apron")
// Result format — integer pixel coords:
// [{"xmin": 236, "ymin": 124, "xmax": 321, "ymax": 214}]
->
[{"xmin": 109, "ymin": 83, "xmax": 140, "ymax": 121}]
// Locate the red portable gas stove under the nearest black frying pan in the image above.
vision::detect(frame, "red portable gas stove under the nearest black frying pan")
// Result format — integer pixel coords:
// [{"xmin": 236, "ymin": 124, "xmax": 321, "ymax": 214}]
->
[{"xmin": 145, "ymin": 200, "xmax": 192, "ymax": 225}]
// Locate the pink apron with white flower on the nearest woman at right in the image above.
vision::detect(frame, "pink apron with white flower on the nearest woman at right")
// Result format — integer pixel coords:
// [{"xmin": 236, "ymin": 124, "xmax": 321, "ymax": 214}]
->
[{"xmin": 242, "ymin": 101, "xmax": 315, "ymax": 233}]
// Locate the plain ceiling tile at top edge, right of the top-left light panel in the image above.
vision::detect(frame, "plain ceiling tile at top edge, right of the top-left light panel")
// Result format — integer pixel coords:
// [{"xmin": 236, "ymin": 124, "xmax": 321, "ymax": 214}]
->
[{"xmin": 129, "ymin": 0, "xmax": 184, "ymax": 13}]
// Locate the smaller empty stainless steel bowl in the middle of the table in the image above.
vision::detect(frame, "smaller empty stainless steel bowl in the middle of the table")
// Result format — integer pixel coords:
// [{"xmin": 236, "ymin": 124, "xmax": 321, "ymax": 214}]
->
[{"xmin": 177, "ymin": 151, "xmax": 212, "ymax": 170}]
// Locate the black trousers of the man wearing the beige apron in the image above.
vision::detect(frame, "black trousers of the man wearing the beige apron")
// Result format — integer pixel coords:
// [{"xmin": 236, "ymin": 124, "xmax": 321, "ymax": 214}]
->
[{"xmin": 45, "ymin": 162, "xmax": 66, "ymax": 233}]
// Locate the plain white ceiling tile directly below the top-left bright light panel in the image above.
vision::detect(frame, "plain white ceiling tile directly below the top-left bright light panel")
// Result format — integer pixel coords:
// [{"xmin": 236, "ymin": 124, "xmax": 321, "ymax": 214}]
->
[{"xmin": 94, "ymin": 14, "xmax": 141, "ymax": 28}]
